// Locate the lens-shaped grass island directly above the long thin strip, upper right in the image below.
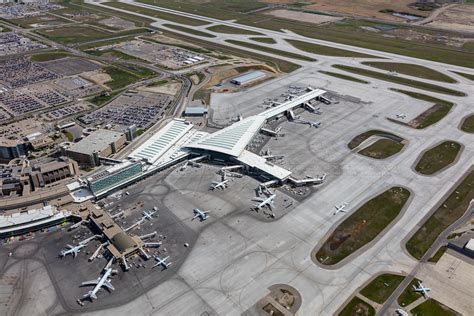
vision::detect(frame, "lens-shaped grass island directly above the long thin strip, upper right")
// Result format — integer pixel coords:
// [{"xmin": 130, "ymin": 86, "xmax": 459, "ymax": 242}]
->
[{"xmin": 362, "ymin": 61, "xmax": 457, "ymax": 83}]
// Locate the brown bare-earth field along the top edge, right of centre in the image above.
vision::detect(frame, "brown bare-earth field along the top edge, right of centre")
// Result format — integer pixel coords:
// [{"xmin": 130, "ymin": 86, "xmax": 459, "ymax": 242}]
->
[{"xmin": 305, "ymin": 0, "xmax": 429, "ymax": 21}]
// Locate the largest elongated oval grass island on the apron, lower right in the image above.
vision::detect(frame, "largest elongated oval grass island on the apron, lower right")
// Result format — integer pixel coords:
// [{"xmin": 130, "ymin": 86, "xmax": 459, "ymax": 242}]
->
[{"xmin": 316, "ymin": 187, "xmax": 410, "ymax": 265}]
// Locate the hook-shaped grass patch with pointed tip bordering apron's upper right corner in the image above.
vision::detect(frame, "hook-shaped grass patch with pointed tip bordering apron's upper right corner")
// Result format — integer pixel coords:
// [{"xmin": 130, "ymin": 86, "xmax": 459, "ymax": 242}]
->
[{"xmin": 390, "ymin": 89, "xmax": 454, "ymax": 129}]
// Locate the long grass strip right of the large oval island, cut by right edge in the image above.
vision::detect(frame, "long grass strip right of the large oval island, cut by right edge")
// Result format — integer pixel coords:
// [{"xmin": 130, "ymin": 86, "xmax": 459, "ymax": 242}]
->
[{"xmin": 405, "ymin": 171, "xmax": 474, "ymax": 260}]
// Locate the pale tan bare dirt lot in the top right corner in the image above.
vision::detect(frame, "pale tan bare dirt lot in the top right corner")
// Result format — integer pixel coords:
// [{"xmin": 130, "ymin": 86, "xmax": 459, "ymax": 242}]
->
[{"xmin": 426, "ymin": 5, "xmax": 474, "ymax": 33}]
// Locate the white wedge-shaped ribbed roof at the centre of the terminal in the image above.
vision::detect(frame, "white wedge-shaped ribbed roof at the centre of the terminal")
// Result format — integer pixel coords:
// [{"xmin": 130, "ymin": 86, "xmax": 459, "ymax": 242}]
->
[{"xmin": 186, "ymin": 115, "xmax": 266, "ymax": 157}]
